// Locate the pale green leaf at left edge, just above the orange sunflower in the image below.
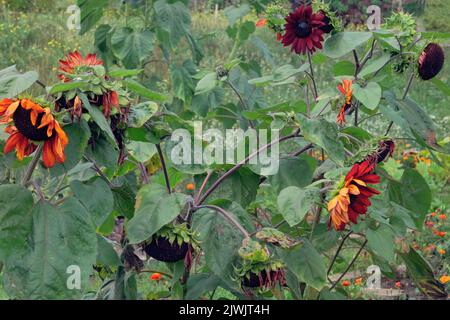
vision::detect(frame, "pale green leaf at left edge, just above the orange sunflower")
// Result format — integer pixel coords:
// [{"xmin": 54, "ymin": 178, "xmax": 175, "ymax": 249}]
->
[{"xmin": 0, "ymin": 66, "xmax": 39, "ymax": 99}]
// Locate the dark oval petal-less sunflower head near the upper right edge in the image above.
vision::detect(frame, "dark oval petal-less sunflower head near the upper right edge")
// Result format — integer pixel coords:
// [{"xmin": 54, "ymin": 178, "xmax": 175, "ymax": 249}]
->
[{"xmin": 418, "ymin": 43, "xmax": 445, "ymax": 80}]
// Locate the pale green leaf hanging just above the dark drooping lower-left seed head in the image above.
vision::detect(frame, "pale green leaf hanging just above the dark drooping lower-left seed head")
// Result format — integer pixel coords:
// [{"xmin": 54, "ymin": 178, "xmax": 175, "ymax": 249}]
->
[{"xmin": 127, "ymin": 184, "xmax": 186, "ymax": 244}]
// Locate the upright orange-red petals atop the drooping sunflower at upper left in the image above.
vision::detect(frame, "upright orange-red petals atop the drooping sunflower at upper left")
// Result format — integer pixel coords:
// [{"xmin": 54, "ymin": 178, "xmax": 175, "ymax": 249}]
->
[{"xmin": 59, "ymin": 51, "xmax": 103, "ymax": 82}]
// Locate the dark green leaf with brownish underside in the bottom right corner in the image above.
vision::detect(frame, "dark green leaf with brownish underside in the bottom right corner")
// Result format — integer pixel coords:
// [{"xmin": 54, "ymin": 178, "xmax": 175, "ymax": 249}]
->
[{"xmin": 399, "ymin": 247, "xmax": 447, "ymax": 298}]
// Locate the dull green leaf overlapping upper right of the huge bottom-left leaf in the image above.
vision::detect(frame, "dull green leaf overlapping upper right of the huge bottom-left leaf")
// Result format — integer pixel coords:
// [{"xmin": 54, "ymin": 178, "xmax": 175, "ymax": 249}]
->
[{"xmin": 70, "ymin": 178, "xmax": 114, "ymax": 227}]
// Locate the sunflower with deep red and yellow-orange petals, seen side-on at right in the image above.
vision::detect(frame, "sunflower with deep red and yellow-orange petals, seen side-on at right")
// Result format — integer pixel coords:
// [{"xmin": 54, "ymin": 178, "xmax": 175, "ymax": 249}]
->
[{"xmin": 328, "ymin": 161, "xmax": 380, "ymax": 230}]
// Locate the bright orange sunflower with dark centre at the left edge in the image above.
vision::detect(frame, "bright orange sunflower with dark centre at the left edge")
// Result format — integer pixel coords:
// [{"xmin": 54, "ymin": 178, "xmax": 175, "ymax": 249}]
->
[{"xmin": 0, "ymin": 99, "xmax": 69, "ymax": 168}]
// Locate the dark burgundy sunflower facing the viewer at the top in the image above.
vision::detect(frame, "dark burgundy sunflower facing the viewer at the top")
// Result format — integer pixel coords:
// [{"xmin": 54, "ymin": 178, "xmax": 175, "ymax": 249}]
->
[{"xmin": 282, "ymin": 5, "xmax": 326, "ymax": 54}]
